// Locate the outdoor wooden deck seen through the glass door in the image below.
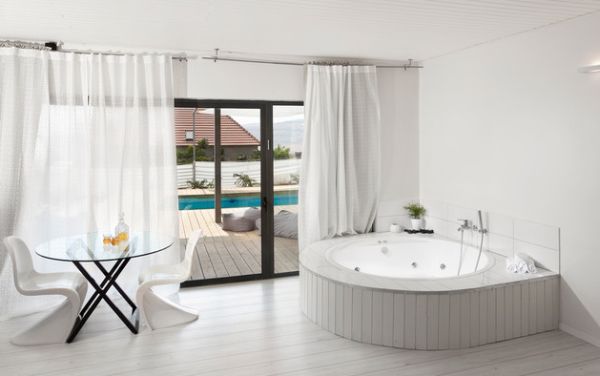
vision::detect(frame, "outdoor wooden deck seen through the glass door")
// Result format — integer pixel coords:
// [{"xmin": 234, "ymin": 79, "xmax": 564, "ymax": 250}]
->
[{"xmin": 179, "ymin": 205, "xmax": 298, "ymax": 280}]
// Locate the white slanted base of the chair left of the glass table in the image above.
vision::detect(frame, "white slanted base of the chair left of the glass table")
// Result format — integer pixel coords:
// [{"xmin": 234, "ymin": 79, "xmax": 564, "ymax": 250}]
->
[{"xmin": 10, "ymin": 299, "xmax": 78, "ymax": 346}]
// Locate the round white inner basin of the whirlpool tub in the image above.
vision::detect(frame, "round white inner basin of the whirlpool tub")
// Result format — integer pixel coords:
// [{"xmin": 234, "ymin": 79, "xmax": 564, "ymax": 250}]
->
[{"xmin": 326, "ymin": 236, "xmax": 491, "ymax": 279}]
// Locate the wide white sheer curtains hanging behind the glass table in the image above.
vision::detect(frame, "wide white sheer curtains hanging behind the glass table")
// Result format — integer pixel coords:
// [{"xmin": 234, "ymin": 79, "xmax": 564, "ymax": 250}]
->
[{"xmin": 0, "ymin": 49, "xmax": 179, "ymax": 317}]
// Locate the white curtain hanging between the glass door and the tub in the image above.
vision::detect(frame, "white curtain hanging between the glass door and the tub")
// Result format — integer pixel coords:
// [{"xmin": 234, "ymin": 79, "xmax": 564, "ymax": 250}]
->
[{"xmin": 299, "ymin": 65, "xmax": 380, "ymax": 250}]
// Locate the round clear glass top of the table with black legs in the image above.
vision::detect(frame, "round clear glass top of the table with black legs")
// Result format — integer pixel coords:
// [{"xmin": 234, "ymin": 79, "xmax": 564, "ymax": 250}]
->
[{"xmin": 35, "ymin": 232, "xmax": 173, "ymax": 262}]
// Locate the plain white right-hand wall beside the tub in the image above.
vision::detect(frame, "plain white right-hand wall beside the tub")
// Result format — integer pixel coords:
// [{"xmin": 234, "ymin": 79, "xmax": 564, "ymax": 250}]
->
[{"xmin": 420, "ymin": 14, "xmax": 600, "ymax": 345}]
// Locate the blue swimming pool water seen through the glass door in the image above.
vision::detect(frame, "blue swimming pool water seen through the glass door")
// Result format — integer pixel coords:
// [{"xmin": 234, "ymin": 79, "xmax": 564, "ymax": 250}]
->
[{"xmin": 179, "ymin": 192, "xmax": 298, "ymax": 210}]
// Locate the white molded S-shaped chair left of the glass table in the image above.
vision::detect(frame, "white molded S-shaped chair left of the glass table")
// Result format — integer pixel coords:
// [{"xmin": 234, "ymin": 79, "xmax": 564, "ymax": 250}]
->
[{"xmin": 4, "ymin": 236, "xmax": 87, "ymax": 345}]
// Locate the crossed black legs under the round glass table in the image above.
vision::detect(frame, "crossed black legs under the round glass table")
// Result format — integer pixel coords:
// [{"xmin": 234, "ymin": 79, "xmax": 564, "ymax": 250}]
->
[{"xmin": 67, "ymin": 259, "xmax": 139, "ymax": 343}]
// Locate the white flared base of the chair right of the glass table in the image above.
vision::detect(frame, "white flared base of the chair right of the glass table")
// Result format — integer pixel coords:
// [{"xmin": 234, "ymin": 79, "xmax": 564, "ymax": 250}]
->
[{"xmin": 138, "ymin": 289, "xmax": 198, "ymax": 329}]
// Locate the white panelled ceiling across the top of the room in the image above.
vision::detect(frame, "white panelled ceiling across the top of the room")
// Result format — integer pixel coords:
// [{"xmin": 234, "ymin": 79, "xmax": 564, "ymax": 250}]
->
[{"xmin": 0, "ymin": 0, "xmax": 600, "ymax": 60}]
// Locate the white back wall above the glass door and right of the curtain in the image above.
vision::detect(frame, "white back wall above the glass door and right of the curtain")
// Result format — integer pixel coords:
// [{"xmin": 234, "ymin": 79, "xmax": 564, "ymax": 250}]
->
[{"xmin": 180, "ymin": 59, "xmax": 419, "ymax": 222}]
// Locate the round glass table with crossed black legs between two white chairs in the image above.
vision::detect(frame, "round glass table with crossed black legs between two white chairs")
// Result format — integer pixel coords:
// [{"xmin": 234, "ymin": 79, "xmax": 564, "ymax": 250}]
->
[{"xmin": 35, "ymin": 232, "xmax": 174, "ymax": 343}]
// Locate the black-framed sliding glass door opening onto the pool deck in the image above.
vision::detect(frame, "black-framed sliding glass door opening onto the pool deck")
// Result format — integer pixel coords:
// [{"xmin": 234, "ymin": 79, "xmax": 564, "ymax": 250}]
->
[{"xmin": 175, "ymin": 99, "xmax": 302, "ymax": 285}]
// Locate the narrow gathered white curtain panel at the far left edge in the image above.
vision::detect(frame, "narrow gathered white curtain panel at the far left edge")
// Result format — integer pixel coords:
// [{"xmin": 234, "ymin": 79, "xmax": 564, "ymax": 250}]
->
[{"xmin": 0, "ymin": 48, "xmax": 47, "ymax": 318}]
